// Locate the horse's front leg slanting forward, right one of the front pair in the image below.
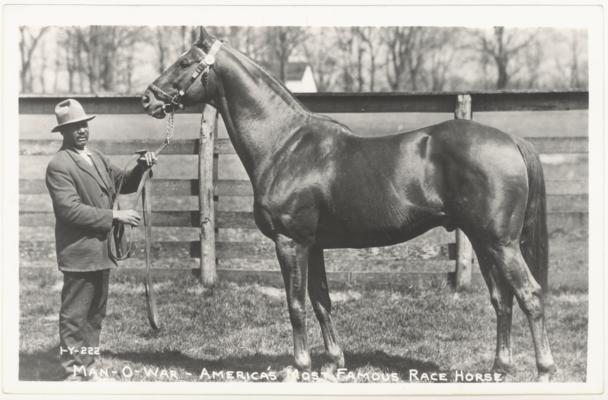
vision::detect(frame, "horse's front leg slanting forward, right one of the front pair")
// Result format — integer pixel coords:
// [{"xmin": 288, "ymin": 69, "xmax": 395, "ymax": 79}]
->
[{"xmin": 308, "ymin": 246, "xmax": 344, "ymax": 368}]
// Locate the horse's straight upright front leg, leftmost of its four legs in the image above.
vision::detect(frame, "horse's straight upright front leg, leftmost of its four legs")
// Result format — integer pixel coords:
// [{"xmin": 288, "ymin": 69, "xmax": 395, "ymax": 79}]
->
[{"xmin": 275, "ymin": 235, "xmax": 310, "ymax": 371}]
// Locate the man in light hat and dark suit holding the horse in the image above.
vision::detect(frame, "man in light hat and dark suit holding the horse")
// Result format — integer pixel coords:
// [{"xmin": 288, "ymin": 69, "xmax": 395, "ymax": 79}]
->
[{"xmin": 46, "ymin": 99, "xmax": 156, "ymax": 380}]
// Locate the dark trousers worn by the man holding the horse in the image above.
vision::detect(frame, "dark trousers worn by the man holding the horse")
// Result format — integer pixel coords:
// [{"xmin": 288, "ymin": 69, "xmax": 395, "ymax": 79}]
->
[{"xmin": 59, "ymin": 269, "xmax": 110, "ymax": 375}]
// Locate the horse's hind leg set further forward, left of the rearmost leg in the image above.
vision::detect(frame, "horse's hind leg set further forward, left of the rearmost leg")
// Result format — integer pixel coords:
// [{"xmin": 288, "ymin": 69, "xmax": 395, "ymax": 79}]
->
[{"xmin": 474, "ymin": 244, "xmax": 513, "ymax": 373}]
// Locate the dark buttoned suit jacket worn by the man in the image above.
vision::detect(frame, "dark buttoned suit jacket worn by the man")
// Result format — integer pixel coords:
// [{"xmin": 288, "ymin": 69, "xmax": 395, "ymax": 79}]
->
[{"xmin": 46, "ymin": 148, "xmax": 144, "ymax": 272}]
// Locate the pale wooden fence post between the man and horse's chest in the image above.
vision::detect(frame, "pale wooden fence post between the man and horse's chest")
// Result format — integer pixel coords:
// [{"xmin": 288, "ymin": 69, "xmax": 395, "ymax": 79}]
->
[{"xmin": 198, "ymin": 105, "xmax": 217, "ymax": 287}]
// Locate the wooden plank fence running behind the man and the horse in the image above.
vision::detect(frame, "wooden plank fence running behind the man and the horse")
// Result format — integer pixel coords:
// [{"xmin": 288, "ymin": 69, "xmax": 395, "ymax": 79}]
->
[{"xmin": 19, "ymin": 92, "xmax": 588, "ymax": 287}]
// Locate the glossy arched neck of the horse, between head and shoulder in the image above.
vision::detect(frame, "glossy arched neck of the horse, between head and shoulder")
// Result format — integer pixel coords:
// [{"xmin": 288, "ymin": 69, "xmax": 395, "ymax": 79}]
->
[{"xmin": 216, "ymin": 48, "xmax": 307, "ymax": 180}]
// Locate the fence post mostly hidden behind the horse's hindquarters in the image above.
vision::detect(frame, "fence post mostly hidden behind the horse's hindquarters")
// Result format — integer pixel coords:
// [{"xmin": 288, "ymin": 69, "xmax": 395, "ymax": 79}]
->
[{"xmin": 454, "ymin": 94, "xmax": 473, "ymax": 290}]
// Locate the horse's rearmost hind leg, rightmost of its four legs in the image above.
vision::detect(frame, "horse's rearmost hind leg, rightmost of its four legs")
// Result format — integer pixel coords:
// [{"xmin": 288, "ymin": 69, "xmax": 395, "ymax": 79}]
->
[{"xmin": 489, "ymin": 241, "xmax": 556, "ymax": 381}]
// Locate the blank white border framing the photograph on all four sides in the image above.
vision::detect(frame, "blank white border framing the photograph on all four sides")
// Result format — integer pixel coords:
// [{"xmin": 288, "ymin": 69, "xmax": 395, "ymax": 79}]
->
[{"xmin": 0, "ymin": 1, "xmax": 607, "ymax": 396}]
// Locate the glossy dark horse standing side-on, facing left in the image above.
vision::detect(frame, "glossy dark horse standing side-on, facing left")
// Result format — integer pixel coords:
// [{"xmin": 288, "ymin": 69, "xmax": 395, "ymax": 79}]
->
[{"xmin": 141, "ymin": 28, "xmax": 556, "ymax": 381}]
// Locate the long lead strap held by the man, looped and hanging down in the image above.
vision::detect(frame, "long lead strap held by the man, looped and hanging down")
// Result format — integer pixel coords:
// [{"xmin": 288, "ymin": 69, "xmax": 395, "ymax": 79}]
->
[{"xmin": 108, "ymin": 112, "xmax": 175, "ymax": 330}]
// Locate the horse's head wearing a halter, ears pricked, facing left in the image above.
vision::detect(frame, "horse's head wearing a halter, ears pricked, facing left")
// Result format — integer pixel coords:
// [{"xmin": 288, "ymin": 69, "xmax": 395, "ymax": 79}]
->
[{"xmin": 141, "ymin": 28, "xmax": 221, "ymax": 118}]
